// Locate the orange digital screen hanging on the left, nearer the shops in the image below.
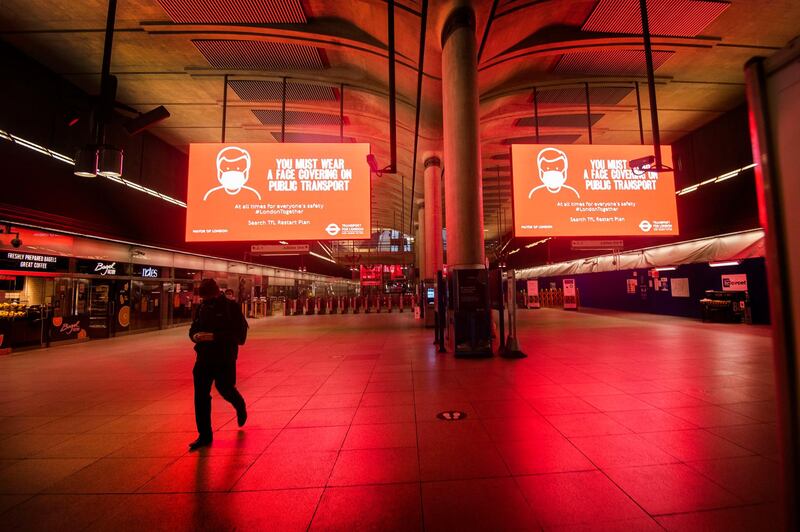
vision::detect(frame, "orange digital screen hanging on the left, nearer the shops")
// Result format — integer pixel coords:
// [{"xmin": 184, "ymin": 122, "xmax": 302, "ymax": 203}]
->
[{"xmin": 186, "ymin": 143, "xmax": 371, "ymax": 242}]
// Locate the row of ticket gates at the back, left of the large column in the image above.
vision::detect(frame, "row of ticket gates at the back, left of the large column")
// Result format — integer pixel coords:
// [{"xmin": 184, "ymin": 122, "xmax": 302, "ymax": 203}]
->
[{"xmin": 283, "ymin": 295, "xmax": 415, "ymax": 316}]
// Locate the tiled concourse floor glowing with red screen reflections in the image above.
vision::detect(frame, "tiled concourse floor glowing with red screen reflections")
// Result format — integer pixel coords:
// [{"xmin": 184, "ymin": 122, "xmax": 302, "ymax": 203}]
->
[{"xmin": 0, "ymin": 309, "xmax": 779, "ymax": 532}]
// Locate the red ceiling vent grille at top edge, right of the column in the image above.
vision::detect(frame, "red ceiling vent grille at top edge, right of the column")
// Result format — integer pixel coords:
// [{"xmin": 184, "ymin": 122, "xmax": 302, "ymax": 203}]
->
[{"xmin": 581, "ymin": 0, "xmax": 730, "ymax": 37}]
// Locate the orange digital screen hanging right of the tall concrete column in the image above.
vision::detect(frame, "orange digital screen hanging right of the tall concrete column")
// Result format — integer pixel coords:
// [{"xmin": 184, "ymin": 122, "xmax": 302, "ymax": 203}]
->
[{"xmin": 511, "ymin": 144, "xmax": 678, "ymax": 237}]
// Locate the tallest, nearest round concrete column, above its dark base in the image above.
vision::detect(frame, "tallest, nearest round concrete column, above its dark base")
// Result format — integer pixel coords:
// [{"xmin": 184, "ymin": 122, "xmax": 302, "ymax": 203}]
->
[{"xmin": 442, "ymin": 2, "xmax": 484, "ymax": 268}]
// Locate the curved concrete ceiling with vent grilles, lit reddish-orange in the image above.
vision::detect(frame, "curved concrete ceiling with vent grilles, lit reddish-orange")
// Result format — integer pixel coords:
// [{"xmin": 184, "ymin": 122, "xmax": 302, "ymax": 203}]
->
[{"xmin": 0, "ymin": 0, "xmax": 800, "ymax": 244}]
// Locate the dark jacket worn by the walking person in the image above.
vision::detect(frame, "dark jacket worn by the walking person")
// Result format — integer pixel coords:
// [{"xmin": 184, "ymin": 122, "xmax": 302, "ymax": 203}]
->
[{"xmin": 189, "ymin": 294, "xmax": 245, "ymax": 359}]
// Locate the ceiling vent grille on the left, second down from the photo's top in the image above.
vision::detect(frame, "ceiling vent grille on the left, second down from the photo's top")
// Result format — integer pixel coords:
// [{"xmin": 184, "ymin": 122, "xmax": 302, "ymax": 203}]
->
[{"xmin": 192, "ymin": 39, "xmax": 327, "ymax": 71}]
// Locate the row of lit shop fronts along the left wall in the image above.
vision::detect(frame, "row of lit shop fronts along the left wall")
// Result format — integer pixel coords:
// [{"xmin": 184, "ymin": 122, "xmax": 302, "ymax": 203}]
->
[{"xmin": 0, "ymin": 224, "xmax": 356, "ymax": 352}]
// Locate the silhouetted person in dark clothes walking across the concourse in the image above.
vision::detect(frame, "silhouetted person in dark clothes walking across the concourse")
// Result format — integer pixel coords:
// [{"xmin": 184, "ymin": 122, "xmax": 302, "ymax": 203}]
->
[{"xmin": 189, "ymin": 279, "xmax": 247, "ymax": 451}]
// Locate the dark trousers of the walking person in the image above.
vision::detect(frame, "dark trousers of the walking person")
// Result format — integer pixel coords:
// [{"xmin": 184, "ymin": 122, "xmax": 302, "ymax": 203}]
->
[{"xmin": 192, "ymin": 357, "xmax": 245, "ymax": 438}]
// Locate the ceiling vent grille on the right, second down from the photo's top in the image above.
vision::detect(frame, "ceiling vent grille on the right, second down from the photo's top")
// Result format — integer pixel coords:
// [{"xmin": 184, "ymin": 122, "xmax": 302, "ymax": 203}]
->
[{"xmin": 553, "ymin": 50, "xmax": 675, "ymax": 76}]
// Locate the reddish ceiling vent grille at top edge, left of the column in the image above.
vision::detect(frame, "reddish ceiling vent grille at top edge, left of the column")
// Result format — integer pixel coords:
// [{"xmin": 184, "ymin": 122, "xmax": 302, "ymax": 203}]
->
[{"xmin": 158, "ymin": 0, "xmax": 308, "ymax": 24}]
